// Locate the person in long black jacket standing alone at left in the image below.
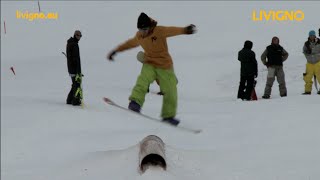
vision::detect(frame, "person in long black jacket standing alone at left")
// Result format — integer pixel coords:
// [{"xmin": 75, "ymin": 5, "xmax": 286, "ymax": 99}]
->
[{"xmin": 66, "ymin": 30, "xmax": 83, "ymax": 106}]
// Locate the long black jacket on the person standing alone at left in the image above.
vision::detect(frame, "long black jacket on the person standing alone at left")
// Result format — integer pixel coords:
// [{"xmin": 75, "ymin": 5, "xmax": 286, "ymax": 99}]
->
[{"xmin": 66, "ymin": 37, "xmax": 81, "ymax": 75}]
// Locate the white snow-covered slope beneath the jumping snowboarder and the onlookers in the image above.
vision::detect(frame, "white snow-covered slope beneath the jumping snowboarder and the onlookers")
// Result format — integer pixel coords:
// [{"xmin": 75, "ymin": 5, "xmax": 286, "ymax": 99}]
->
[{"xmin": 1, "ymin": 1, "xmax": 320, "ymax": 180}]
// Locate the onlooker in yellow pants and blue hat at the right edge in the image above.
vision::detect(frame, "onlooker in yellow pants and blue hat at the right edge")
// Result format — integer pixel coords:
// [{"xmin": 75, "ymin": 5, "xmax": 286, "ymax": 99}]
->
[{"xmin": 302, "ymin": 30, "xmax": 320, "ymax": 95}]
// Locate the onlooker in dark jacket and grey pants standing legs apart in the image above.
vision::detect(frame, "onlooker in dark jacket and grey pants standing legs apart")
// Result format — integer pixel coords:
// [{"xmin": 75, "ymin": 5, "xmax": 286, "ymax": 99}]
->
[{"xmin": 261, "ymin": 37, "xmax": 289, "ymax": 99}]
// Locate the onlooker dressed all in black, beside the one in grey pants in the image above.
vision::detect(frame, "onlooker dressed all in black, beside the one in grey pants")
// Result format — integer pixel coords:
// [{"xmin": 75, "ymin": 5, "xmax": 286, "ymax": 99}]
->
[{"xmin": 238, "ymin": 41, "xmax": 258, "ymax": 100}]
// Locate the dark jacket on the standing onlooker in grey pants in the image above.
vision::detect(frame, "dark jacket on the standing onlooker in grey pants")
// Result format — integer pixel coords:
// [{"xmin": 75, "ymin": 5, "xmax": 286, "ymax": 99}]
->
[{"xmin": 261, "ymin": 44, "xmax": 289, "ymax": 66}]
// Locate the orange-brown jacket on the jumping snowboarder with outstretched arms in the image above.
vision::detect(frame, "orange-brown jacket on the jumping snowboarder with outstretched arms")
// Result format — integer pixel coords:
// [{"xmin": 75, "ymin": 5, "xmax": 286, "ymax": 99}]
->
[{"xmin": 116, "ymin": 21, "xmax": 185, "ymax": 69}]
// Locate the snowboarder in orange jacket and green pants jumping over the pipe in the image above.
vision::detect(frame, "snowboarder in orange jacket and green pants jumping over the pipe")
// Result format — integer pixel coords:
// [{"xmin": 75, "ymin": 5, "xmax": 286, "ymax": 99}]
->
[{"xmin": 107, "ymin": 13, "xmax": 196, "ymax": 125}]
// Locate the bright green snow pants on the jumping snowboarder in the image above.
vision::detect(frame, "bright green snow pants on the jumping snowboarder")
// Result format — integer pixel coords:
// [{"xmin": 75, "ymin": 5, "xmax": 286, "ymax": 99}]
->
[{"xmin": 129, "ymin": 64, "xmax": 178, "ymax": 118}]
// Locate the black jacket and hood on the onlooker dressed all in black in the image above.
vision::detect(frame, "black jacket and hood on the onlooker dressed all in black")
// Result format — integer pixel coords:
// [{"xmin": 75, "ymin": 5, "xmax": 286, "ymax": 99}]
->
[{"xmin": 238, "ymin": 41, "xmax": 258, "ymax": 76}]
